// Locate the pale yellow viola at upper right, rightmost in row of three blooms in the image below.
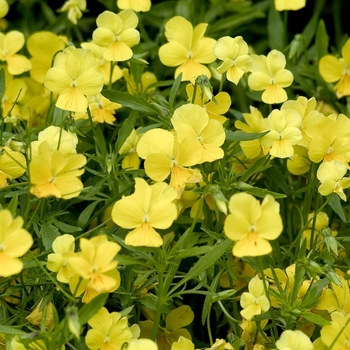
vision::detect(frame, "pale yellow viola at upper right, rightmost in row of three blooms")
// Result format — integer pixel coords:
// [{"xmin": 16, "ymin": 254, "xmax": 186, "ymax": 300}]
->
[{"xmin": 248, "ymin": 50, "xmax": 294, "ymax": 104}]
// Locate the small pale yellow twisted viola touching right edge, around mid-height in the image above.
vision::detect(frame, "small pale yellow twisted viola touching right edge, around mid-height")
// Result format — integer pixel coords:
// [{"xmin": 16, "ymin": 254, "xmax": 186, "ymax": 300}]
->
[{"xmin": 316, "ymin": 160, "xmax": 350, "ymax": 201}]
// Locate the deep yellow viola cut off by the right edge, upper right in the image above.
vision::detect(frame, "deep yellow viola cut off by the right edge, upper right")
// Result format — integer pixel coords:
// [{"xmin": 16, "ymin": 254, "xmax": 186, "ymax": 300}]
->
[{"xmin": 319, "ymin": 39, "xmax": 350, "ymax": 98}]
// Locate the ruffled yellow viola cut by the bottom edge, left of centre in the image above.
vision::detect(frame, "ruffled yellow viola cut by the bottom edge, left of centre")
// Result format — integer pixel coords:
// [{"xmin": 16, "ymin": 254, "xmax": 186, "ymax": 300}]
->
[{"xmin": 85, "ymin": 307, "xmax": 133, "ymax": 350}]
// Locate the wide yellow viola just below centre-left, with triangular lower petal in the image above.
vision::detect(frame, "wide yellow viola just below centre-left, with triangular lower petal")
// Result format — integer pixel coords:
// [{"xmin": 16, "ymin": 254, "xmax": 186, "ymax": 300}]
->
[{"xmin": 112, "ymin": 178, "xmax": 177, "ymax": 247}]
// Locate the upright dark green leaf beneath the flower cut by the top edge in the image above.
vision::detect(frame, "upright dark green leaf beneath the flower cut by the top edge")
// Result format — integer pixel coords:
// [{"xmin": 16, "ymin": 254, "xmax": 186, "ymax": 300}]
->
[{"xmin": 267, "ymin": 2, "xmax": 285, "ymax": 51}]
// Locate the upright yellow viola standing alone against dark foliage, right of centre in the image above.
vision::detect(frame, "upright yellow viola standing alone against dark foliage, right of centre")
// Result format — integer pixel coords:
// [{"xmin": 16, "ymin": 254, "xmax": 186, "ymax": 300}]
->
[{"xmin": 224, "ymin": 192, "xmax": 283, "ymax": 258}]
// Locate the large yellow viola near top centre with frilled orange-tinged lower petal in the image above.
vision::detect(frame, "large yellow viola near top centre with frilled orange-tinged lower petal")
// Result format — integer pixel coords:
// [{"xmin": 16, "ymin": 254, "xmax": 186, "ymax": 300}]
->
[{"xmin": 159, "ymin": 16, "xmax": 216, "ymax": 81}]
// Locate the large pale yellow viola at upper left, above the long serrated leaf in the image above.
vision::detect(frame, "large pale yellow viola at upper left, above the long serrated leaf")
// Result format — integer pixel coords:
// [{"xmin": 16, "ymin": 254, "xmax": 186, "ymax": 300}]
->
[{"xmin": 44, "ymin": 46, "xmax": 103, "ymax": 112}]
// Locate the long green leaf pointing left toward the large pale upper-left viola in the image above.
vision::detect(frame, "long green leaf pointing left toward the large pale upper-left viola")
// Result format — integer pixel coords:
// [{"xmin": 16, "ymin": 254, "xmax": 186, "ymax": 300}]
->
[{"xmin": 101, "ymin": 90, "xmax": 157, "ymax": 114}]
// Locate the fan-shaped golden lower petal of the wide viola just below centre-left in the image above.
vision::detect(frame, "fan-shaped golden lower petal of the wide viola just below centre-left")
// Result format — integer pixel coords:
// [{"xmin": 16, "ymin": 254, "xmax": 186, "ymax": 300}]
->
[{"xmin": 125, "ymin": 223, "xmax": 163, "ymax": 247}]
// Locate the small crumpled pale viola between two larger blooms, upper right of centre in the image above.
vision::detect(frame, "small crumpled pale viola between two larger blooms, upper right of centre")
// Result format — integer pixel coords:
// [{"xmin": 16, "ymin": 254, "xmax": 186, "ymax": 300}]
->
[{"xmin": 213, "ymin": 36, "xmax": 252, "ymax": 85}]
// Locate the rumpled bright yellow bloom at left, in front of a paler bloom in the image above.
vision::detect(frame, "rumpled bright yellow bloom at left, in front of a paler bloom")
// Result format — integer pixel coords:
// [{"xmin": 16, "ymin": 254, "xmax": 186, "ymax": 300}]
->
[{"xmin": 29, "ymin": 141, "xmax": 86, "ymax": 199}]
